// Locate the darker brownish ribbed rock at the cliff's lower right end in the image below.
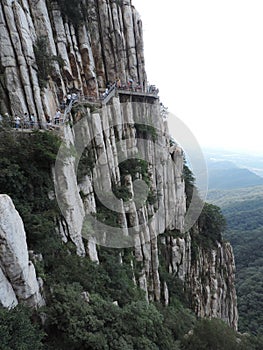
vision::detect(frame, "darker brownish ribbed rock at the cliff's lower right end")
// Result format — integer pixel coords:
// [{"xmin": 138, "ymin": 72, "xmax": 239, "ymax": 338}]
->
[{"xmin": 161, "ymin": 234, "xmax": 238, "ymax": 329}]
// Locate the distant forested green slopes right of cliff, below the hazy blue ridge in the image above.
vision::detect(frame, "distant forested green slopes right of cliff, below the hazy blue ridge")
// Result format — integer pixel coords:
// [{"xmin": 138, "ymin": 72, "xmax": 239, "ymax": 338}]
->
[{"xmin": 209, "ymin": 186, "xmax": 263, "ymax": 335}]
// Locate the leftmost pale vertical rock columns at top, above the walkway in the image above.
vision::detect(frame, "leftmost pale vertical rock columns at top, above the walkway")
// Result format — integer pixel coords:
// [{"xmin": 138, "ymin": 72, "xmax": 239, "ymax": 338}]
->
[{"xmin": 1, "ymin": 1, "xmax": 44, "ymax": 122}]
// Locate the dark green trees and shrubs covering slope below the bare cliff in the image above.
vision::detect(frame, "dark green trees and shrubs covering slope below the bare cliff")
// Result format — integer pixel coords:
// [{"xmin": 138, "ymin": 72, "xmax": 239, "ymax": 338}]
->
[{"xmin": 0, "ymin": 131, "xmax": 262, "ymax": 350}]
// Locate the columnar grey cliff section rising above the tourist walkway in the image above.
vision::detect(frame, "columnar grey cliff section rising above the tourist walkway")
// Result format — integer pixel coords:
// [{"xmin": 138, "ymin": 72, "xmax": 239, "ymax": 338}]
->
[{"xmin": 0, "ymin": 0, "xmax": 146, "ymax": 126}]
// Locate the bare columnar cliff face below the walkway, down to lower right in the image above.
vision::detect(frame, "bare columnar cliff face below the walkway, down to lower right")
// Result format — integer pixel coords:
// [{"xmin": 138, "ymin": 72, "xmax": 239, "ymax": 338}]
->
[{"xmin": 55, "ymin": 96, "xmax": 237, "ymax": 328}]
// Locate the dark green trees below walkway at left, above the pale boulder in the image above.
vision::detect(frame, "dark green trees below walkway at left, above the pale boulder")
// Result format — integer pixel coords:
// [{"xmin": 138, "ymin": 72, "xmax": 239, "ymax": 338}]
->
[{"xmin": 0, "ymin": 131, "xmax": 60, "ymax": 252}]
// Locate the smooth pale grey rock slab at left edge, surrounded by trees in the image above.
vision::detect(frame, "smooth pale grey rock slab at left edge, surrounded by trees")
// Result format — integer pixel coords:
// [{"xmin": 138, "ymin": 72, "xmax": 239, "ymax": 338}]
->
[{"xmin": 0, "ymin": 194, "xmax": 44, "ymax": 307}]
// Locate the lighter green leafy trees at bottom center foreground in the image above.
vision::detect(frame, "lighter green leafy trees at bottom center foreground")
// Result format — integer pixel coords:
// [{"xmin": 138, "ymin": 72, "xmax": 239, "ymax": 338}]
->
[{"xmin": 46, "ymin": 283, "xmax": 177, "ymax": 350}]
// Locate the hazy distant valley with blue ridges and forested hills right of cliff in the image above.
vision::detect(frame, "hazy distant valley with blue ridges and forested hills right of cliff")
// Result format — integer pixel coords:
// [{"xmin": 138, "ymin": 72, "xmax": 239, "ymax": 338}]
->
[{"xmin": 205, "ymin": 150, "xmax": 263, "ymax": 334}]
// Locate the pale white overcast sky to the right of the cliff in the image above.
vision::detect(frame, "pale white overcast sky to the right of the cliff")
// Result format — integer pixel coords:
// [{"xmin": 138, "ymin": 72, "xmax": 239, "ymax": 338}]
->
[{"xmin": 132, "ymin": 0, "xmax": 263, "ymax": 155}]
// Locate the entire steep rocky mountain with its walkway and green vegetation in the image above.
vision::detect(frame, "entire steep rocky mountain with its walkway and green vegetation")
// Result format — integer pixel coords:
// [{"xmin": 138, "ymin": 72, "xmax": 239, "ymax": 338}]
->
[{"xmin": 0, "ymin": 0, "xmax": 262, "ymax": 350}]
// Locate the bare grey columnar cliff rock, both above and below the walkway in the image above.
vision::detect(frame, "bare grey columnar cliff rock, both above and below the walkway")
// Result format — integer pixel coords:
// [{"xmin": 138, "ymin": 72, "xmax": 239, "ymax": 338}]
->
[{"xmin": 0, "ymin": 0, "xmax": 237, "ymax": 328}]
